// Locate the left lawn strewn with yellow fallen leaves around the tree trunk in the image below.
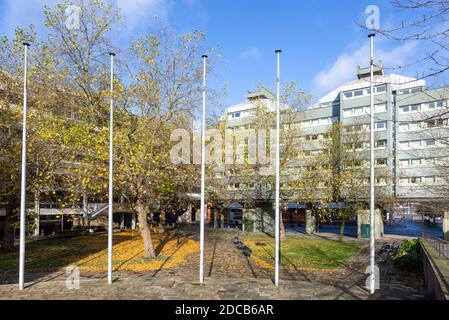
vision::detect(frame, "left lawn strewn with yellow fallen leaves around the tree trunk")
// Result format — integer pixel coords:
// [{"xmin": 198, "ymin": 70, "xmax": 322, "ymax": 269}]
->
[{"xmin": 0, "ymin": 232, "xmax": 199, "ymax": 273}]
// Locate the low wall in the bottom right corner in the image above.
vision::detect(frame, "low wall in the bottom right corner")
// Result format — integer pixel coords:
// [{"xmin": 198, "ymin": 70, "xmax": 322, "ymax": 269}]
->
[{"xmin": 420, "ymin": 239, "xmax": 449, "ymax": 300}]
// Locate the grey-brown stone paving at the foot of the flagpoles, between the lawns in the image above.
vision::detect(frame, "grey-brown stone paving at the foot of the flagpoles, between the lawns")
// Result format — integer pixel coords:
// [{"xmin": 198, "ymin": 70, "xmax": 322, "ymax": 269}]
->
[{"xmin": 0, "ymin": 228, "xmax": 424, "ymax": 300}]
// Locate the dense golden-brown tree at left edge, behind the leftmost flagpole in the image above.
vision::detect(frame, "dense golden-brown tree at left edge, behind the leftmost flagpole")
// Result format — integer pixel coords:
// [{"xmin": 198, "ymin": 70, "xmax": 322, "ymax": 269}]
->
[{"xmin": 0, "ymin": 28, "xmax": 75, "ymax": 249}]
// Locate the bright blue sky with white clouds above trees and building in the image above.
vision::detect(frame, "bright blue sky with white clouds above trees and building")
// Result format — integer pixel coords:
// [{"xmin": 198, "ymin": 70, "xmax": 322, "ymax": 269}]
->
[{"xmin": 0, "ymin": 0, "xmax": 438, "ymax": 106}]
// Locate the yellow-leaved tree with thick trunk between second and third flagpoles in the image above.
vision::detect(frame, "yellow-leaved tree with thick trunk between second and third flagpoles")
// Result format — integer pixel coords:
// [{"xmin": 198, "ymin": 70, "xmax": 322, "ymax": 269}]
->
[{"xmin": 116, "ymin": 32, "xmax": 204, "ymax": 258}]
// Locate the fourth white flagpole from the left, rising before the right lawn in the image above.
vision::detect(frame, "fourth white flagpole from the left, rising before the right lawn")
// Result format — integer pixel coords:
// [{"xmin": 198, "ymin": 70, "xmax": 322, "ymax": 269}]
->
[{"xmin": 274, "ymin": 50, "xmax": 282, "ymax": 286}]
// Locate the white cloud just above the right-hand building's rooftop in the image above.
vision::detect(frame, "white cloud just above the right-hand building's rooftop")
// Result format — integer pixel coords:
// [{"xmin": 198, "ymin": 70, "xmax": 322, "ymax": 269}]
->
[{"xmin": 313, "ymin": 42, "xmax": 417, "ymax": 95}]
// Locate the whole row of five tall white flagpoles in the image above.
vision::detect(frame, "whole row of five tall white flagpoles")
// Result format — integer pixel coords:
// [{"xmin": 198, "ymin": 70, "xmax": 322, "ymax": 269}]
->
[{"xmin": 19, "ymin": 34, "xmax": 375, "ymax": 294}]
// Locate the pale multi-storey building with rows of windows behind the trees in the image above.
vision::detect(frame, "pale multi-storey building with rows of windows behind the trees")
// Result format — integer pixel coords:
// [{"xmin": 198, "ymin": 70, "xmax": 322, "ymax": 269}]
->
[{"xmin": 222, "ymin": 65, "xmax": 449, "ymax": 231}]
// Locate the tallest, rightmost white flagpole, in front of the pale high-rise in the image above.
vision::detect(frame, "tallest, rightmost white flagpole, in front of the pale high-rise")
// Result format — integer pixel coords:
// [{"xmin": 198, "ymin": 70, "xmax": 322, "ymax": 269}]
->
[{"xmin": 369, "ymin": 34, "xmax": 376, "ymax": 294}]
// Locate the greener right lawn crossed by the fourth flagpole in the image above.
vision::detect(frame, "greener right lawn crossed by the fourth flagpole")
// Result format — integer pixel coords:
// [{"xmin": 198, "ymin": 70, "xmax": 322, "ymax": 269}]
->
[{"xmin": 244, "ymin": 234, "xmax": 363, "ymax": 270}]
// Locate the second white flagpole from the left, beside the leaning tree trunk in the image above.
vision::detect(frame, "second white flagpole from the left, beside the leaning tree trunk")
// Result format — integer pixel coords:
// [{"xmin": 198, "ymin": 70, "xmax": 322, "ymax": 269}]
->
[{"xmin": 108, "ymin": 52, "xmax": 115, "ymax": 284}]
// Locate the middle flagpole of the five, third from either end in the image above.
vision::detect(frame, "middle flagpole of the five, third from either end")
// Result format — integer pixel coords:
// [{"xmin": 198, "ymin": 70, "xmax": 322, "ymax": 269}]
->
[{"xmin": 200, "ymin": 55, "xmax": 207, "ymax": 284}]
